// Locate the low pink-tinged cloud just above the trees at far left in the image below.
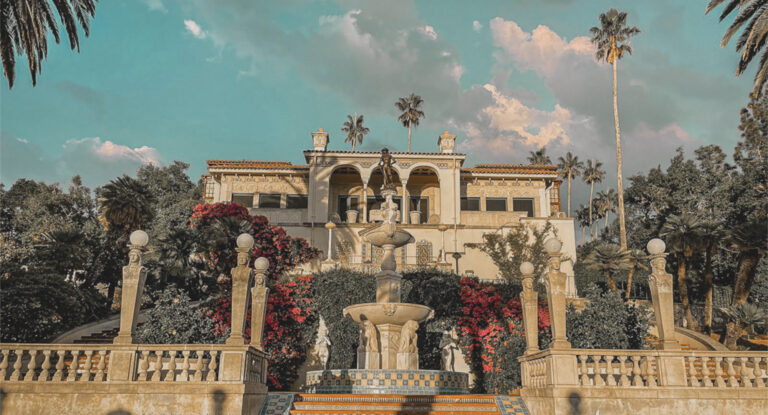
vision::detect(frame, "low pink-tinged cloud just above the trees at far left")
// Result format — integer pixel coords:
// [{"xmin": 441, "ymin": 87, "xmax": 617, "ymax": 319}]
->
[{"xmin": 0, "ymin": 132, "xmax": 165, "ymax": 187}]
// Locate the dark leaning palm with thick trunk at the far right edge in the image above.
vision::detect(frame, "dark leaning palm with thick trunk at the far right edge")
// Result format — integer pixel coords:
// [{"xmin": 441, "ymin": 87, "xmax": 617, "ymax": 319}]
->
[{"xmin": 726, "ymin": 219, "xmax": 768, "ymax": 305}]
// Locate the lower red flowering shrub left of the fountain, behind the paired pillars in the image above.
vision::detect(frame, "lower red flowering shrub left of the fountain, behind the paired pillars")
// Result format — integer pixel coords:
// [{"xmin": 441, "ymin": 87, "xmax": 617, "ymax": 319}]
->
[{"xmin": 213, "ymin": 276, "xmax": 316, "ymax": 390}]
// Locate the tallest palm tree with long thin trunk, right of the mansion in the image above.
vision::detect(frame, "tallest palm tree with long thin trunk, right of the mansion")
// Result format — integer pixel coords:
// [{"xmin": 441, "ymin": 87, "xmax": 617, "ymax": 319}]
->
[{"xmin": 589, "ymin": 8, "xmax": 640, "ymax": 249}]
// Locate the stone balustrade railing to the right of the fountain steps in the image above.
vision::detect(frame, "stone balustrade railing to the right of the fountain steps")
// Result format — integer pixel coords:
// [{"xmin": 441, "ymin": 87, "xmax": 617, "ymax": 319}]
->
[{"xmin": 520, "ymin": 349, "xmax": 768, "ymax": 393}]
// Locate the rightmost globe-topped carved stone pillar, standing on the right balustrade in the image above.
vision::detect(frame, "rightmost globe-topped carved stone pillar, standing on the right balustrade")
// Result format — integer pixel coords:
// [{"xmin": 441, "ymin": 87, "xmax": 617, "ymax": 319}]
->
[{"xmin": 646, "ymin": 239, "xmax": 680, "ymax": 350}]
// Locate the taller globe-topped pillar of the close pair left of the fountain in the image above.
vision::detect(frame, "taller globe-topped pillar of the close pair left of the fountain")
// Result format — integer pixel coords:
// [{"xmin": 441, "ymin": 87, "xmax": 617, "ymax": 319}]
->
[{"xmin": 227, "ymin": 233, "xmax": 253, "ymax": 345}]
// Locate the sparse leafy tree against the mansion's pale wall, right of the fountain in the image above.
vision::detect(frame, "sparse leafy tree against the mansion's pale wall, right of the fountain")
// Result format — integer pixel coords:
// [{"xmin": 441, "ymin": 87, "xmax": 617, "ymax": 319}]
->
[{"xmin": 467, "ymin": 222, "xmax": 556, "ymax": 285}]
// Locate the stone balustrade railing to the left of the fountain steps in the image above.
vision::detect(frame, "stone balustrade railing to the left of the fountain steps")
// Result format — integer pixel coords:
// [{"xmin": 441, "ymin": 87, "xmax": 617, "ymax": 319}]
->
[{"xmin": 0, "ymin": 344, "xmax": 267, "ymax": 384}]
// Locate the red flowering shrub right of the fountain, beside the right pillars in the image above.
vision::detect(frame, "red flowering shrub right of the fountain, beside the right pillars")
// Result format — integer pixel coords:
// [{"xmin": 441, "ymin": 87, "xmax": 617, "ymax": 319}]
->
[{"xmin": 457, "ymin": 278, "xmax": 550, "ymax": 393}]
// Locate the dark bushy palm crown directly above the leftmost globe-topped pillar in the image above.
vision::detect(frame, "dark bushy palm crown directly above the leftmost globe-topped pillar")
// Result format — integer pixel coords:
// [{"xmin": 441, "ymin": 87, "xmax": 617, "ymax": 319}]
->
[{"xmin": 97, "ymin": 175, "xmax": 154, "ymax": 233}]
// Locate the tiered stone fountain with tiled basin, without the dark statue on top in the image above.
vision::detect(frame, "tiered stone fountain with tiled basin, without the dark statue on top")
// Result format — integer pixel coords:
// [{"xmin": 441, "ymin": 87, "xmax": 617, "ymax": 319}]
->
[{"xmin": 306, "ymin": 179, "xmax": 468, "ymax": 395}]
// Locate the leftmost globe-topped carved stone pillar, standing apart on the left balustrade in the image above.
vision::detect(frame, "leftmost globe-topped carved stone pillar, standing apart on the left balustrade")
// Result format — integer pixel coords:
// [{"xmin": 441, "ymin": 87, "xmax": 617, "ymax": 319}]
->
[{"xmin": 114, "ymin": 231, "xmax": 149, "ymax": 344}]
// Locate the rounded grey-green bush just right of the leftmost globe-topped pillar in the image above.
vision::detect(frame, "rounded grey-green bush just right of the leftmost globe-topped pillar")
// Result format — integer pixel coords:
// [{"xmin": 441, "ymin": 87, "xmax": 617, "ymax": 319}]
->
[{"xmin": 136, "ymin": 286, "xmax": 218, "ymax": 344}]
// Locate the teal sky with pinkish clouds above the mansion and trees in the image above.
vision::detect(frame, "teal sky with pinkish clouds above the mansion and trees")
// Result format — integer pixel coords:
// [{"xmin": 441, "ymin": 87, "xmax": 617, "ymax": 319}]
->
[{"xmin": 0, "ymin": 0, "xmax": 754, "ymax": 213}]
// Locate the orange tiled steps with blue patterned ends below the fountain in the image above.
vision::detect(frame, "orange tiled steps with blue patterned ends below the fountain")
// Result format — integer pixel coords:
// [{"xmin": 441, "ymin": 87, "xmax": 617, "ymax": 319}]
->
[{"xmin": 261, "ymin": 393, "xmax": 530, "ymax": 415}]
